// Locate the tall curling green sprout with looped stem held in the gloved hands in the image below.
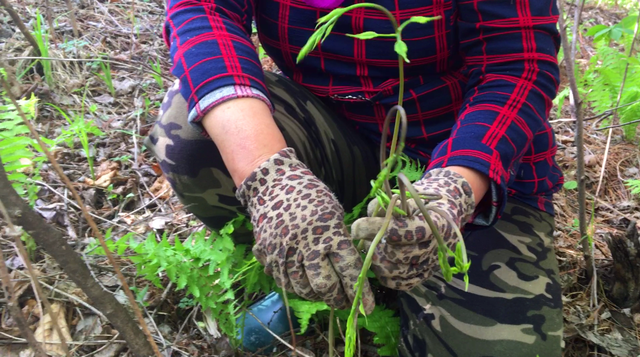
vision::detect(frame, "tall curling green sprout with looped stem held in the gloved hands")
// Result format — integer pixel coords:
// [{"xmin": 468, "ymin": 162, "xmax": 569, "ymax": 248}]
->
[{"xmin": 297, "ymin": 3, "xmax": 471, "ymax": 357}]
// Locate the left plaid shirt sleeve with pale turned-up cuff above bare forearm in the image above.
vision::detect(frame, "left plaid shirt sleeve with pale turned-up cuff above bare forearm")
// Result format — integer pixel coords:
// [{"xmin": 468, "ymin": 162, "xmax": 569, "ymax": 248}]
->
[{"xmin": 163, "ymin": 0, "xmax": 272, "ymax": 131}]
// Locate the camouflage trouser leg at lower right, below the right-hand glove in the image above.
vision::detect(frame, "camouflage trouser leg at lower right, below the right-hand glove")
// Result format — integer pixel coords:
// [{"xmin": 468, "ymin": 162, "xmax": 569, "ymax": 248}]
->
[{"xmin": 399, "ymin": 199, "xmax": 562, "ymax": 357}]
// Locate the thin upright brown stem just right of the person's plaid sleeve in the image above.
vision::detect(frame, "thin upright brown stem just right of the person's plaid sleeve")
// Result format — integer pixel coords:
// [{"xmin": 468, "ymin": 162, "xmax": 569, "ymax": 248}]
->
[{"xmin": 558, "ymin": 0, "xmax": 594, "ymax": 279}]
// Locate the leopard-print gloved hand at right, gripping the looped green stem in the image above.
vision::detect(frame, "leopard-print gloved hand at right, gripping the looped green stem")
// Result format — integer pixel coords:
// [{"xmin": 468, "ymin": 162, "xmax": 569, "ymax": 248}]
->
[{"xmin": 351, "ymin": 169, "xmax": 475, "ymax": 290}]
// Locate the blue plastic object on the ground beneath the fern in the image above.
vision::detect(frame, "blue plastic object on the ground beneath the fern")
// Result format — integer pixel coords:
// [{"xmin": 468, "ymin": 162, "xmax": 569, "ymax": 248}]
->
[{"xmin": 237, "ymin": 292, "xmax": 299, "ymax": 352}]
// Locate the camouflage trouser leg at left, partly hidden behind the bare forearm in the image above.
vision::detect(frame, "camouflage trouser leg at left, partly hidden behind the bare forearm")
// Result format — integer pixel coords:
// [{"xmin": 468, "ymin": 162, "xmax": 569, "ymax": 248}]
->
[{"xmin": 145, "ymin": 73, "xmax": 378, "ymax": 243}]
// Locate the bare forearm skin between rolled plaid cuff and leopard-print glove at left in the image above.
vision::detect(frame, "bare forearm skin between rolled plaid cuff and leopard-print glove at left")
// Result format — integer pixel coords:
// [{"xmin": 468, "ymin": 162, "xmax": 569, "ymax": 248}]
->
[{"xmin": 202, "ymin": 98, "xmax": 287, "ymax": 186}]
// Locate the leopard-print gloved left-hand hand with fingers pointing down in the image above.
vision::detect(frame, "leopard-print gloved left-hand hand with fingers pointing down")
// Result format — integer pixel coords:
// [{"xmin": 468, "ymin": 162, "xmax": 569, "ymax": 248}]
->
[{"xmin": 236, "ymin": 148, "xmax": 375, "ymax": 314}]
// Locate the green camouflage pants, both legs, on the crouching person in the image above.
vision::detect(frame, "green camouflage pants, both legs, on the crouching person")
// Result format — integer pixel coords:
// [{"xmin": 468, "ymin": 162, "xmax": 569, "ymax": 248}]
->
[{"xmin": 145, "ymin": 73, "xmax": 562, "ymax": 357}]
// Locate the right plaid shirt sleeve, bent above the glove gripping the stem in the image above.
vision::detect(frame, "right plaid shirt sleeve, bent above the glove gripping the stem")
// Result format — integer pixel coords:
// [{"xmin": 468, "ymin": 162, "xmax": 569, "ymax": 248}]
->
[{"xmin": 429, "ymin": 0, "xmax": 559, "ymax": 225}]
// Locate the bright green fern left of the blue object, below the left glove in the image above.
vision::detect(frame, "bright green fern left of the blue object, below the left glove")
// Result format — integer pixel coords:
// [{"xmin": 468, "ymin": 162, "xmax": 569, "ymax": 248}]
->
[{"xmin": 87, "ymin": 216, "xmax": 262, "ymax": 342}]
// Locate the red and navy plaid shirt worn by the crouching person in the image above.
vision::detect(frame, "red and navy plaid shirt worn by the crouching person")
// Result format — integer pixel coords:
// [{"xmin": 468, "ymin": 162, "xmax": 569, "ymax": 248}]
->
[{"xmin": 164, "ymin": 0, "xmax": 563, "ymax": 224}]
